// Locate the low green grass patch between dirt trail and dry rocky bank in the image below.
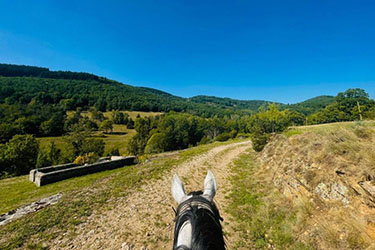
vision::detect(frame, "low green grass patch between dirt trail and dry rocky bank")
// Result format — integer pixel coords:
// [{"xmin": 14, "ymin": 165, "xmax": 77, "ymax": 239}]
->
[{"xmin": 227, "ymin": 149, "xmax": 314, "ymax": 249}]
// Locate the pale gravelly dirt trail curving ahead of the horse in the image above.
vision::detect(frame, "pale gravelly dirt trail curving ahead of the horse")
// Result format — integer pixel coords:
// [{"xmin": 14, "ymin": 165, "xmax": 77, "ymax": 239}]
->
[{"xmin": 51, "ymin": 141, "xmax": 251, "ymax": 249}]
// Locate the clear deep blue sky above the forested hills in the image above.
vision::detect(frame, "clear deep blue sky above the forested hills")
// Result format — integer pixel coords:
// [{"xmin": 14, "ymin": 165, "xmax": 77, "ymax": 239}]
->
[{"xmin": 0, "ymin": 0, "xmax": 375, "ymax": 103}]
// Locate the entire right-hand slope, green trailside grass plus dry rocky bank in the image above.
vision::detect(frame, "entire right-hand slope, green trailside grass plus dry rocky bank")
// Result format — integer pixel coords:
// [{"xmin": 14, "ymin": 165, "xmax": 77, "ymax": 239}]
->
[{"xmin": 222, "ymin": 121, "xmax": 375, "ymax": 249}]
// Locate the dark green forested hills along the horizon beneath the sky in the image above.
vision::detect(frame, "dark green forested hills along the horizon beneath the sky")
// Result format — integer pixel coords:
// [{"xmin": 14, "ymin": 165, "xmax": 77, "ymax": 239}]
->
[{"xmin": 0, "ymin": 64, "xmax": 334, "ymax": 117}]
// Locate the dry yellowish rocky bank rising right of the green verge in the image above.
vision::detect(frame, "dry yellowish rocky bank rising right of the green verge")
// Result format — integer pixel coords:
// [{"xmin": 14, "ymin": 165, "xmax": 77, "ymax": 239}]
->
[{"xmin": 255, "ymin": 121, "xmax": 375, "ymax": 249}]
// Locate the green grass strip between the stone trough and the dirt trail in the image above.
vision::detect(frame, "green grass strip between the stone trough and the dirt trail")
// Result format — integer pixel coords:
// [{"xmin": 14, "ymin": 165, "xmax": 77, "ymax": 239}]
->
[{"xmin": 0, "ymin": 141, "xmax": 241, "ymax": 250}]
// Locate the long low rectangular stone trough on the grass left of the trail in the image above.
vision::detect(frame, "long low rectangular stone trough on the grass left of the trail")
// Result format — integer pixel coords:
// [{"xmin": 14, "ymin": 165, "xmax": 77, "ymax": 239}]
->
[{"xmin": 29, "ymin": 156, "xmax": 135, "ymax": 187}]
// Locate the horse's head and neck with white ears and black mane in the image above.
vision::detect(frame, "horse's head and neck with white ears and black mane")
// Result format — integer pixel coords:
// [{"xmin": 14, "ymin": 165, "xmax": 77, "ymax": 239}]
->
[{"xmin": 172, "ymin": 170, "xmax": 225, "ymax": 250}]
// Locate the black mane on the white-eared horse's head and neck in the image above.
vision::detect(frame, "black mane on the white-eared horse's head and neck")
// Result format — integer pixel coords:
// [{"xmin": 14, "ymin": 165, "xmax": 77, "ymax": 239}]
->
[{"xmin": 174, "ymin": 191, "xmax": 225, "ymax": 250}]
